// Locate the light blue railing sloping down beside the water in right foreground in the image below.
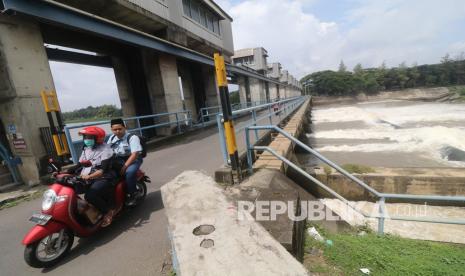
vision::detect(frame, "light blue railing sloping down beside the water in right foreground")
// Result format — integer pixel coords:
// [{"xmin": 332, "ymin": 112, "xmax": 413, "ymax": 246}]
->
[{"xmin": 245, "ymin": 125, "xmax": 465, "ymax": 234}]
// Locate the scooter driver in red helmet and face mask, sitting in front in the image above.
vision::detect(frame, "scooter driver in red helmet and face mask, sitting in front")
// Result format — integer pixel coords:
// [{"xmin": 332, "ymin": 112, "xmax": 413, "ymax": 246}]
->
[{"xmin": 68, "ymin": 126, "xmax": 116, "ymax": 227}]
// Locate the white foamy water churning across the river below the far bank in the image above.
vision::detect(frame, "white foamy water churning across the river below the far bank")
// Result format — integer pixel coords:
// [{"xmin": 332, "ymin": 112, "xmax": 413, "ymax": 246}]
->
[{"xmin": 310, "ymin": 101, "xmax": 465, "ymax": 167}]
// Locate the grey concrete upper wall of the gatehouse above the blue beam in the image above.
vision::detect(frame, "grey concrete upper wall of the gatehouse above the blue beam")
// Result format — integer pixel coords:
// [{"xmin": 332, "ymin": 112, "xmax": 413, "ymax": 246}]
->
[{"xmin": 54, "ymin": 0, "xmax": 234, "ymax": 56}]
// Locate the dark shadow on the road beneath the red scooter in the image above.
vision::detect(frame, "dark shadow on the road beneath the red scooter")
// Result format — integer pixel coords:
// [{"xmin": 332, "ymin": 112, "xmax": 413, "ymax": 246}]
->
[{"xmin": 42, "ymin": 190, "xmax": 164, "ymax": 273}]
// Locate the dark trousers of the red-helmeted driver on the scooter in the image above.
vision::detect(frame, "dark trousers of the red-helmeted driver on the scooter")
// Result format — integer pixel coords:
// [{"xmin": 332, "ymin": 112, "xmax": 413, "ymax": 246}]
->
[{"xmin": 85, "ymin": 178, "xmax": 114, "ymax": 214}]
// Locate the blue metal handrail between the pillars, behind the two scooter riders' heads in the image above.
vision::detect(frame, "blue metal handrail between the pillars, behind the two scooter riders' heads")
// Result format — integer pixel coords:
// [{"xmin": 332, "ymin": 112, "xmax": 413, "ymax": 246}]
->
[{"xmin": 64, "ymin": 110, "xmax": 192, "ymax": 163}]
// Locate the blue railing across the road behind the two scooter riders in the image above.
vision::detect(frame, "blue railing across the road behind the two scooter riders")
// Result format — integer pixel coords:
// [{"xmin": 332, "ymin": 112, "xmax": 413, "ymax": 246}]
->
[{"xmin": 65, "ymin": 110, "xmax": 192, "ymax": 163}]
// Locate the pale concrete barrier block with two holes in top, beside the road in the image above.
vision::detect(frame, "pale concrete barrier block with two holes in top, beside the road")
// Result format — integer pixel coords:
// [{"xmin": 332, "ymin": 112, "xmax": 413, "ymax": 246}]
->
[{"xmin": 161, "ymin": 171, "xmax": 308, "ymax": 276}]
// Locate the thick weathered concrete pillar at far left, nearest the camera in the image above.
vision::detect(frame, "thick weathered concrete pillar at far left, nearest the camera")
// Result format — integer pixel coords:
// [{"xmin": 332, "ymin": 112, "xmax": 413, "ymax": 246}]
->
[{"xmin": 0, "ymin": 15, "xmax": 55, "ymax": 185}]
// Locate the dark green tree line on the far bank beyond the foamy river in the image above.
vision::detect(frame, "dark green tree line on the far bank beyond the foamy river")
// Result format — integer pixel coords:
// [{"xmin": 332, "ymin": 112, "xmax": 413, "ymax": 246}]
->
[{"xmin": 301, "ymin": 53, "xmax": 465, "ymax": 96}]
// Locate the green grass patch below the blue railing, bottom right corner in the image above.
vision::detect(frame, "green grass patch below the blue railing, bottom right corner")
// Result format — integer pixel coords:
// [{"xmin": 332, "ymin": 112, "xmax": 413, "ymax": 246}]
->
[{"xmin": 305, "ymin": 223, "xmax": 465, "ymax": 275}]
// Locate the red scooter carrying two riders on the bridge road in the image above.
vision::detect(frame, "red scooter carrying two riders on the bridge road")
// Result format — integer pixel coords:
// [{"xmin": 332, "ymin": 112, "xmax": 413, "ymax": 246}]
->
[{"xmin": 22, "ymin": 164, "xmax": 150, "ymax": 268}]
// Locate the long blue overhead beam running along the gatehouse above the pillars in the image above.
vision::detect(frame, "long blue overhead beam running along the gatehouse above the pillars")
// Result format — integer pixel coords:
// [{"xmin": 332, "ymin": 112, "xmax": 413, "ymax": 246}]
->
[{"xmin": 0, "ymin": 0, "xmax": 285, "ymax": 85}]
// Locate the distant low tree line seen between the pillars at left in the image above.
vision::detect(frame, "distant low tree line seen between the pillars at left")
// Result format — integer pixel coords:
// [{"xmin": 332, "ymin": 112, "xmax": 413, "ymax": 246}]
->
[{"xmin": 62, "ymin": 104, "xmax": 123, "ymax": 121}]
